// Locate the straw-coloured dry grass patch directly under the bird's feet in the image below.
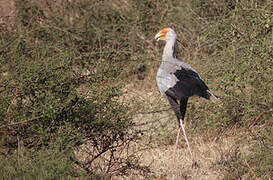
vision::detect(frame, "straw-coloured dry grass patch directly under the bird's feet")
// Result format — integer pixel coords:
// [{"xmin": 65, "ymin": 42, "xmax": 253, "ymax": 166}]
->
[{"xmin": 139, "ymin": 137, "xmax": 239, "ymax": 179}]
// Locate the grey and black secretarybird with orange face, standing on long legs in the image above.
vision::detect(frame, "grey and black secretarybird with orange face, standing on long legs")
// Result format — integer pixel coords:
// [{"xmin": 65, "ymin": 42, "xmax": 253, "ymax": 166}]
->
[{"xmin": 155, "ymin": 28, "xmax": 218, "ymax": 156}]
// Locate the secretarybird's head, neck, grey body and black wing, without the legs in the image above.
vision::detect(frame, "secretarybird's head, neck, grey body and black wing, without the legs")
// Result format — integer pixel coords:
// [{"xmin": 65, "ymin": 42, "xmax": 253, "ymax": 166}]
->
[{"xmin": 156, "ymin": 28, "xmax": 217, "ymax": 108}]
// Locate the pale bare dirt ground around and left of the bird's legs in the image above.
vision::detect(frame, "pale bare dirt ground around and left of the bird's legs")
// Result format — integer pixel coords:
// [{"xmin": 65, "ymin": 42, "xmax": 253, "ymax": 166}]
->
[{"xmin": 117, "ymin": 79, "xmax": 248, "ymax": 180}]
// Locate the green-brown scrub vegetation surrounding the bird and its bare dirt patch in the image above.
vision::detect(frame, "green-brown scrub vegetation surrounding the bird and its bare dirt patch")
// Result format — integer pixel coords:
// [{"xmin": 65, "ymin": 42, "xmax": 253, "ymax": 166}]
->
[{"xmin": 0, "ymin": 0, "xmax": 273, "ymax": 179}]
